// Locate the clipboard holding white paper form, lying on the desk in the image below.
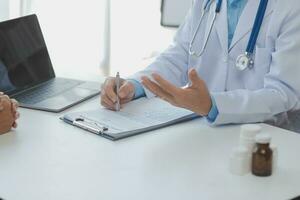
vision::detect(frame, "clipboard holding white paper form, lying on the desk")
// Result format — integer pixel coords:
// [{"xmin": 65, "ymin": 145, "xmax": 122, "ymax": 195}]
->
[{"xmin": 60, "ymin": 98, "xmax": 199, "ymax": 141}]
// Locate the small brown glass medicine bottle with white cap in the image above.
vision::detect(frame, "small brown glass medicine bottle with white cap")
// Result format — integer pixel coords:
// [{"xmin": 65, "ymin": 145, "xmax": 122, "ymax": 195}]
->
[{"xmin": 252, "ymin": 134, "xmax": 273, "ymax": 176}]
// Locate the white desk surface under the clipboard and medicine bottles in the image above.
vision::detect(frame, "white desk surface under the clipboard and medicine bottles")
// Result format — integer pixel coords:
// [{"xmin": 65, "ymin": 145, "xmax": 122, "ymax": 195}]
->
[{"xmin": 0, "ymin": 98, "xmax": 300, "ymax": 200}]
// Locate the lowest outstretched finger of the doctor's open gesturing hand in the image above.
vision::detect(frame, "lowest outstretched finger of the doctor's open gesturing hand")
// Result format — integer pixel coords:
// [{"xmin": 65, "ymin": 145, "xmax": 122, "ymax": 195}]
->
[{"xmin": 142, "ymin": 77, "xmax": 175, "ymax": 104}]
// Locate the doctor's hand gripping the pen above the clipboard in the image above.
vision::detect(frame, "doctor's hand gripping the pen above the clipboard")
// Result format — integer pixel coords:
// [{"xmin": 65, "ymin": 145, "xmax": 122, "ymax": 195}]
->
[{"xmin": 101, "ymin": 77, "xmax": 135, "ymax": 110}]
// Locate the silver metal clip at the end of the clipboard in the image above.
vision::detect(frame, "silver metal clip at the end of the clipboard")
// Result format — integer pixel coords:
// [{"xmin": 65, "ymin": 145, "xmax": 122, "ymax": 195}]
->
[{"xmin": 73, "ymin": 116, "xmax": 108, "ymax": 135}]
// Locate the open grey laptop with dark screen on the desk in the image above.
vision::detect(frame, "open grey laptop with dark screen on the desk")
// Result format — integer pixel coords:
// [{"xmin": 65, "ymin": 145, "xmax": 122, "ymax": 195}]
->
[{"xmin": 0, "ymin": 15, "xmax": 100, "ymax": 112}]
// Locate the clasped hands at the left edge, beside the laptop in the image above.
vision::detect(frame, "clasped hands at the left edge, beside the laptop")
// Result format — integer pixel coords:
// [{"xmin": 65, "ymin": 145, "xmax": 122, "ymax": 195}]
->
[{"xmin": 0, "ymin": 93, "xmax": 20, "ymax": 134}]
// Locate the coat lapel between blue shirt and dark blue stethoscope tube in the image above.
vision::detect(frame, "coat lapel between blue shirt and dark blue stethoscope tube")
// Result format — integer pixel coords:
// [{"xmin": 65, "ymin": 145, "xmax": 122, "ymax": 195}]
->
[{"xmin": 229, "ymin": 0, "xmax": 273, "ymax": 51}]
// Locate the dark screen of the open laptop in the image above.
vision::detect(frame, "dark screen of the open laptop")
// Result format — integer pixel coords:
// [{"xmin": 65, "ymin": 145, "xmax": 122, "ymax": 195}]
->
[{"xmin": 0, "ymin": 15, "xmax": 55, "ymax": 94}]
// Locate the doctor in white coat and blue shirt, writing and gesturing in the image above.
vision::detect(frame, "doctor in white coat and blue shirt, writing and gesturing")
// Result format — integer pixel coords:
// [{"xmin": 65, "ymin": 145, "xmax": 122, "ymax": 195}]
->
[{"xmin": 101, "ymin": 0, "xmax": 300, "ymax": 125}]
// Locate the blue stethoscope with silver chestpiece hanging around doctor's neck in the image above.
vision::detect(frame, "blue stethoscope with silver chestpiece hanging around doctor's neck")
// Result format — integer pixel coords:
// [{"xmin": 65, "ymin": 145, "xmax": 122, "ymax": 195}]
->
[{"xmin": 189, "ymin": 0, "xmax": 268, "ymax": 71}]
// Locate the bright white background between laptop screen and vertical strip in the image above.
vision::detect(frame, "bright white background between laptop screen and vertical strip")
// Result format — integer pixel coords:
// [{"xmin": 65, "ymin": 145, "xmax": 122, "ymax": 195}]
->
[{"xmin": 27, "ymin": 0, "xmax": 105, "ymax": 80}]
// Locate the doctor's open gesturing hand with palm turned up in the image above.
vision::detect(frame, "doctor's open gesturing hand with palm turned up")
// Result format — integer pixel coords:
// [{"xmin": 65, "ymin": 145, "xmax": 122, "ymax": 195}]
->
[{"xmin": 142, "ymin": 69, "xmax": 212, "ymax": 116}]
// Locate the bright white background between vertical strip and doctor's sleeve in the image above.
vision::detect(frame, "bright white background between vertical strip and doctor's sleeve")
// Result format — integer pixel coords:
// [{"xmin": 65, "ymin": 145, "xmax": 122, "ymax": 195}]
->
[{"xmin": 111, "ymin": 0, "xmax": 175, "ymax": 76}]
